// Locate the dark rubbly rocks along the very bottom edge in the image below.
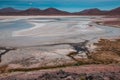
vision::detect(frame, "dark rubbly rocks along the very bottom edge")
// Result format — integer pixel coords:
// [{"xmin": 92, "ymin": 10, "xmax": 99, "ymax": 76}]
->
[{"xmin": 0, "ymin": 70, "xmax": 120, "ymax": 80}]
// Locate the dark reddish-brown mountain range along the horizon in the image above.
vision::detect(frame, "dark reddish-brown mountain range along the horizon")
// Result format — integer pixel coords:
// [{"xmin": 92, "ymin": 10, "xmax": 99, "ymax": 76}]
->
[{"xmin": 0, "ymin": 7, "xmax": 120, "ymax": 15}]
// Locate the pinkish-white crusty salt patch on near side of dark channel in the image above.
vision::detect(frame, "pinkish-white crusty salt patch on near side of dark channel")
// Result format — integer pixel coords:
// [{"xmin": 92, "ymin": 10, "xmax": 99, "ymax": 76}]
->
[{"xmin": 0, "ymin": 48, "xmax": 74, "ymax": 68}]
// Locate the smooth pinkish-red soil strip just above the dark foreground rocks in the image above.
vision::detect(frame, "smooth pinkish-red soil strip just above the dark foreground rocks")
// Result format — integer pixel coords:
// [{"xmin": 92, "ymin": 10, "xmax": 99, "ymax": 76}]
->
[{"xmin": 0, "ymin": 65, "xmax": 120, "ymax": 80}]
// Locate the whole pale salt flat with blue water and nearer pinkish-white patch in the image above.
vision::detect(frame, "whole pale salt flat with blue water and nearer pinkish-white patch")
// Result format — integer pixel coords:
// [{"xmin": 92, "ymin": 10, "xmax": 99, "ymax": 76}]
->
[{"xmin": 0, "ymin": 16, "xmax": 120, "ymax": 68}]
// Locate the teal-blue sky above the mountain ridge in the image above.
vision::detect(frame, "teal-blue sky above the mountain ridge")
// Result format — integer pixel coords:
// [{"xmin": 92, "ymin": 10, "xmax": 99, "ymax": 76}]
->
[{"xmin": 0, "ymin": 0, "xmax": 120, "ymax": 12}]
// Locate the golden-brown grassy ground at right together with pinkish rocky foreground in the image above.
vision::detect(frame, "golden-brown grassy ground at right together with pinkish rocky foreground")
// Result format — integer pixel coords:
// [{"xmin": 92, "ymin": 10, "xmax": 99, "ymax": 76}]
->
[{"xmin": 0, "ymin": 39, "xmax": 120, "ymax": 80}]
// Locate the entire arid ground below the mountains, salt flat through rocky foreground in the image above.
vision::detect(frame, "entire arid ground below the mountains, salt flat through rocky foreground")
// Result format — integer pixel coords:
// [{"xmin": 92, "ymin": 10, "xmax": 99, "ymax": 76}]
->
[{"xmin": 0, "ymin": 16, "xmax": 120, "ymax": 80}]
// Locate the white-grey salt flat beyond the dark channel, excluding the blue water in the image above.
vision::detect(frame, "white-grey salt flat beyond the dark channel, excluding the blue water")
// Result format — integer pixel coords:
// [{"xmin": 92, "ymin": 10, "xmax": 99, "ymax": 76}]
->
[{"xmin": 0, "ymin": 16, "xmax": 120, "ymax": 47}]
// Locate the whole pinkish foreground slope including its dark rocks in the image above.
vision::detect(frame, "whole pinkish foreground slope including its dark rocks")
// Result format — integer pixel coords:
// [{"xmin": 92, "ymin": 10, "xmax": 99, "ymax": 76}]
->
[{"xmin": 0, "ymin": 65, "xmax": 120, "ymax": 80}]
